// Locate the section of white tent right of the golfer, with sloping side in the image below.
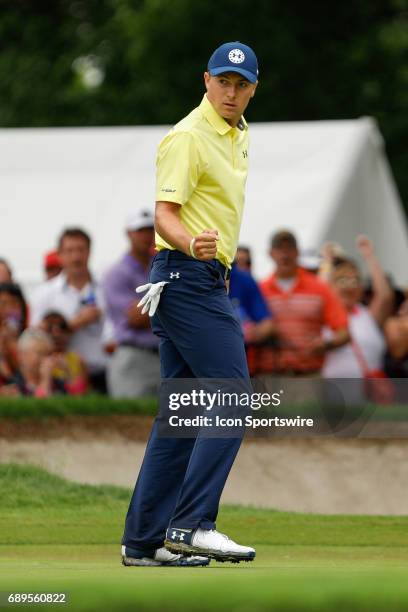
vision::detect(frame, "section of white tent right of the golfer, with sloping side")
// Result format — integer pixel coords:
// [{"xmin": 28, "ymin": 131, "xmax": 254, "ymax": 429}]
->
[{"xmin": 241, "ymin": 118, "xmax": 408, "ymax": 286}]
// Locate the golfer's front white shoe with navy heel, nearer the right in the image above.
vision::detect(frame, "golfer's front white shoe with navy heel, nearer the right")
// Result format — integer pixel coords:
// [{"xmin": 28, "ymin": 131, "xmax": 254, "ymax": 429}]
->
[{"xmin": 164, "ymin": 527, "xmax": 256, "ymax": 563}]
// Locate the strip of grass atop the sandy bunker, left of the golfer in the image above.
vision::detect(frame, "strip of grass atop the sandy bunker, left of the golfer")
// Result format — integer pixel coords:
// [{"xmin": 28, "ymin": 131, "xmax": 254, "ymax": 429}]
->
[{"xmin": 0, "ymin": 395, "xmax": 157, "ymax": 419}]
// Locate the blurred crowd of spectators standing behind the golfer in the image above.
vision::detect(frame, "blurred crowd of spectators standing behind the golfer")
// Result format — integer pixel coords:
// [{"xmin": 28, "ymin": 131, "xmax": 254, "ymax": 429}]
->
[{"xmin": 0, "ymin": 211, "xmax": 408, "ymax": 397}]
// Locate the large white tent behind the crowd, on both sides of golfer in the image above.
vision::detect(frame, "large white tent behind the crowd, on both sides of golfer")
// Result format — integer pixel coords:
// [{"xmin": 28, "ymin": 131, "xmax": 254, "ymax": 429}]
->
[{"xmin": 0, "ymin": 118, "xmax": 408, "ymax": 298}]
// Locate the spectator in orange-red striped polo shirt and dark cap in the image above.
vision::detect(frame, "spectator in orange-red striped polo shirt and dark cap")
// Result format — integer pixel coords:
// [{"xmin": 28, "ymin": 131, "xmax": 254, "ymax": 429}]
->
[{"xmin": 253, "ymin": 230, "xmax": 349, "ymax": 376}]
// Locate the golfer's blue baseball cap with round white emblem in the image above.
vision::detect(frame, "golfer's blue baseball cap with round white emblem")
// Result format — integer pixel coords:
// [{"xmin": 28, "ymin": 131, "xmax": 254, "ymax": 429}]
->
[{"xmin": 208, "ymin": 40, "xmax": 259, "ymax": 83}]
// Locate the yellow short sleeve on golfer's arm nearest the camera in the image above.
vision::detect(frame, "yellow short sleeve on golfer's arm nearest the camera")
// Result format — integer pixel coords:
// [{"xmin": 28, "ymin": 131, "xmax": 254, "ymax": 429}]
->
[{"xmin": 156, "ymin": 131, "xmax": 201, "ymax": 205}]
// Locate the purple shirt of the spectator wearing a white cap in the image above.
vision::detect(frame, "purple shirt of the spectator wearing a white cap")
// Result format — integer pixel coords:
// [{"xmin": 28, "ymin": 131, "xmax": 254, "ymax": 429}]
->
[{"xmin": 103, "ymin": 253, "xmax": 159, "ymax": 348}]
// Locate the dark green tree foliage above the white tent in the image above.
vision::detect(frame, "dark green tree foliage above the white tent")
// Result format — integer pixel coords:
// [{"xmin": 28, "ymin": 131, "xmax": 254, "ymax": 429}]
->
[{"xmin": 0, "ymin": 0, "xmax": 408, "ymax": 208}]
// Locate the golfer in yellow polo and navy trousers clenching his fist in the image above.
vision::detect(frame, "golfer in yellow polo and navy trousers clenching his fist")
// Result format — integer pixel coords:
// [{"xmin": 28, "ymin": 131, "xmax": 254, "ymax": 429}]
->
[{"xmin": 122, "ymin": 42, "xmax": 258, "ymax": 565}]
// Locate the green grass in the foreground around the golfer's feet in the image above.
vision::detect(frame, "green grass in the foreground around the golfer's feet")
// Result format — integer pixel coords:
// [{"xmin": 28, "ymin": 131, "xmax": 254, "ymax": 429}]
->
[{"xmin": 0, "ymin": 465, "xmax": 408, "ymax": 612}]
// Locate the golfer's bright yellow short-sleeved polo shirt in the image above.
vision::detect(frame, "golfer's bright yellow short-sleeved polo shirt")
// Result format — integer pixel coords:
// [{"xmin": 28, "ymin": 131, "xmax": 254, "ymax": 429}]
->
[{"xmin": 156, "ymin": 95, "xmax": 248, "ymax": 268}]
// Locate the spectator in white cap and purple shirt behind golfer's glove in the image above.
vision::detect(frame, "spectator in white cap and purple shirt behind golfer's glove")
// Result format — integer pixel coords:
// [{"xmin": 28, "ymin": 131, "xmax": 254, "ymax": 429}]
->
[{"xmin": 103, "ymin": 210, "xmax": 160, "ymax": 397}]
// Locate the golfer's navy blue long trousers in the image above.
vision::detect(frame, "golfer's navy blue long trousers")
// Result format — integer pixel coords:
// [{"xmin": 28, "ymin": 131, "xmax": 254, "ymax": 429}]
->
[{"xmin": 122, "ymin": 250, "xmax": 249, "ymax": 551}]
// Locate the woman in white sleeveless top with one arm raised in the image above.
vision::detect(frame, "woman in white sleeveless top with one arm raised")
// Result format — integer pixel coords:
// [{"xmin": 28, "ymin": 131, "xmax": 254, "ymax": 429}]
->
[{"xmin": 323, "ymin": 236, "xmax": 393, "ymax": 378}]
